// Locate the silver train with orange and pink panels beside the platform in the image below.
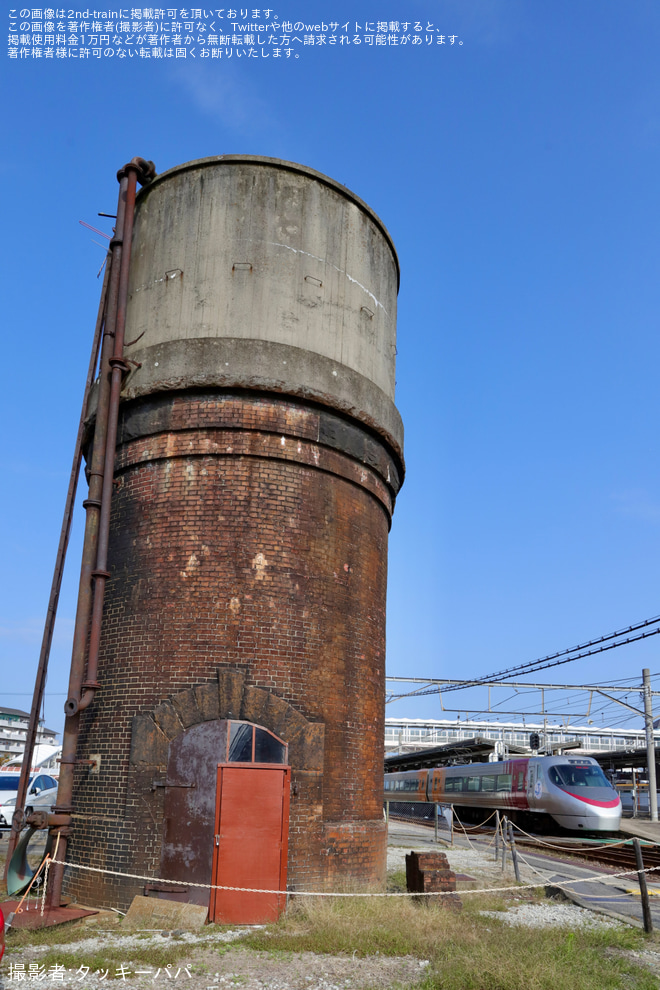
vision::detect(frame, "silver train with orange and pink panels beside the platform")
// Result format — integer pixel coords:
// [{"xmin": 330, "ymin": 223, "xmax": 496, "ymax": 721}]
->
[{"xmin": 385, "ymin": 756, "xmax": 621, "ymax": 832}]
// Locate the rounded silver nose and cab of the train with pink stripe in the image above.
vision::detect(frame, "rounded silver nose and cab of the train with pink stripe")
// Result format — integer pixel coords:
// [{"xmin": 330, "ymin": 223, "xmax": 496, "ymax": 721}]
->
[{"xmin": 528, "ymin": 756, "xmax": 621, "ymax": 832}]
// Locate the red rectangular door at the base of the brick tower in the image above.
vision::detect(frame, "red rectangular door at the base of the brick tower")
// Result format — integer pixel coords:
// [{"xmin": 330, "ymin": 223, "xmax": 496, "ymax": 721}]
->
[{"xmin": 209, "ymin": 763, "xmax": 291, "ymax": 925}]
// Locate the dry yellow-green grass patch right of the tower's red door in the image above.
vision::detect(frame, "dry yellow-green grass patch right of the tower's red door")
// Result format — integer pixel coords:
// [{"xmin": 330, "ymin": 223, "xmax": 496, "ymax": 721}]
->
[{"xmin": 241, "ymin": 895, "xmax": 658, "ymax": 990}]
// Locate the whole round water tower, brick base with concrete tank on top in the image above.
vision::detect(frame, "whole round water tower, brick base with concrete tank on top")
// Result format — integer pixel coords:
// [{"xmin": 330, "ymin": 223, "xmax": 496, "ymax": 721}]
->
[{"xmin": 67, "ymin": 156, "xmax": 403, "ymax": 909}]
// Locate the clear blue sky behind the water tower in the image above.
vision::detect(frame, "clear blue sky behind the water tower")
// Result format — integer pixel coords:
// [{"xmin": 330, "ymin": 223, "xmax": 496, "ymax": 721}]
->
[{"xmin": 0, "ymin": 0, "xmax": 660, "ymax": 744}]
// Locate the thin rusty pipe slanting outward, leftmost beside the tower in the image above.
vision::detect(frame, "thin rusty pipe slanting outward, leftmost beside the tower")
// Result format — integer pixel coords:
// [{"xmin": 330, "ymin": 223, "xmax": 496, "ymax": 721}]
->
[{"xmin": 4, "ymin": 256, "xmax": 111, "ymax": 880}]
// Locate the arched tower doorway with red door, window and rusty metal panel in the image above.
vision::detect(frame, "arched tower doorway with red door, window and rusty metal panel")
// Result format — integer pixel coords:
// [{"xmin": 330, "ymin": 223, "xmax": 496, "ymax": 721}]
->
[{"xmin": 155, "ymin": 719, "xmax": 291, "ymax": 924}]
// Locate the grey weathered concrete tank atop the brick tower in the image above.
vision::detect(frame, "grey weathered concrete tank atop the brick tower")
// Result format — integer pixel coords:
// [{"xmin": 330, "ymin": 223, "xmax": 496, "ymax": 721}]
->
[{"xmin": 114, "ymin": 155, "xmax": 403, "ymax": 460}]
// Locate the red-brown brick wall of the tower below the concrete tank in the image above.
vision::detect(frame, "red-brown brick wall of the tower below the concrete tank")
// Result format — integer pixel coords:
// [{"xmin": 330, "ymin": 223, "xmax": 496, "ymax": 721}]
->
[{"xmin": 67, "ymin": 391, "xmax": 401, "ymax": 907}]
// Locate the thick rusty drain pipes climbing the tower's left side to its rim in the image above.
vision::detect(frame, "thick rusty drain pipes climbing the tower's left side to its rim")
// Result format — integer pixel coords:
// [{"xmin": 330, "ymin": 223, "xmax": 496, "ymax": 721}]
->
[{"xmin": 48, "ymin": 158, "xmax": 156, "ymax": 907}]
